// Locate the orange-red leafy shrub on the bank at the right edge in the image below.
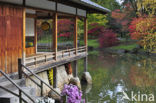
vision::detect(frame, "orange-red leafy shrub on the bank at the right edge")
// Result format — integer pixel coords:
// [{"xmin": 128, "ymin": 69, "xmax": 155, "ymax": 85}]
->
[{"xmin": 129, "ymin": 16, "xmax": 156, "ymax": 52}]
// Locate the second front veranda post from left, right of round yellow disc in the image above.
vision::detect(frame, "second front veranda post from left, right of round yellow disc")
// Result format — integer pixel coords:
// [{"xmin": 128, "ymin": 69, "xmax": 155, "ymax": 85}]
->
[{"xmin": 53, "ymin": 12, "xmax": 58, "ymax": 60}]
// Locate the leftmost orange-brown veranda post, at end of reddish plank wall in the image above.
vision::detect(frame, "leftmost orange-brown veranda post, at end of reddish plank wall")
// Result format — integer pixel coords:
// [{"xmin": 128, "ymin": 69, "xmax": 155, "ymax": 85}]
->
[{"xmin": 22, "ymin": 8, "xmax": 26, "ymax": 65}]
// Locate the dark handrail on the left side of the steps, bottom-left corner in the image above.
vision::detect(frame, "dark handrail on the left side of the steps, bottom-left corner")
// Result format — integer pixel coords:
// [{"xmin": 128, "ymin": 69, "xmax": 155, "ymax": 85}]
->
[{"xmin": 0, "ymin": 70, "xmax": 35, "ymax": 103}]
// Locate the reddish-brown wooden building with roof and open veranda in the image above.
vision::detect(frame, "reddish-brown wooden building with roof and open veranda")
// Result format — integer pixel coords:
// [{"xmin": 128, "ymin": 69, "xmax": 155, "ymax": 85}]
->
[{"xmin": 0, "ymin": 0, "xmax": 109, "ymax": 74}]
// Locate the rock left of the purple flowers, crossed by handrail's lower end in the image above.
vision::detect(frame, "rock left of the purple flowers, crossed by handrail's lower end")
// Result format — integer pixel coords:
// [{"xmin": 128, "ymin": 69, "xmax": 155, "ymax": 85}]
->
[{"xmin": 48, "ymin": 88, "xmax": 61, "ymax": 100}]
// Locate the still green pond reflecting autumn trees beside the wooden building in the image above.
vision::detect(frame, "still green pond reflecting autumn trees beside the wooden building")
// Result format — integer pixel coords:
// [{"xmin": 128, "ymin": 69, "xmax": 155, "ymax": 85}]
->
[{"xmin": 79, "ymin": 51, "xmax": 156, "ymax": 103}]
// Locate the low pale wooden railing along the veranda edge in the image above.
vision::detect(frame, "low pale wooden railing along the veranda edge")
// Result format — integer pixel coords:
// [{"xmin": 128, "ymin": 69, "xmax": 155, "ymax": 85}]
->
[{"xmin": 25, "ymin": 46, "xmax": 87, "ymax": 66}]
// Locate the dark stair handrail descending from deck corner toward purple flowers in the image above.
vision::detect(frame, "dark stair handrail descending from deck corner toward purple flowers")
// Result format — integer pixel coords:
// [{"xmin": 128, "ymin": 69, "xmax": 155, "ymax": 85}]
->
[{"xmin": 21, "ymin": 64, "xmax": 61, "ymax": 97}]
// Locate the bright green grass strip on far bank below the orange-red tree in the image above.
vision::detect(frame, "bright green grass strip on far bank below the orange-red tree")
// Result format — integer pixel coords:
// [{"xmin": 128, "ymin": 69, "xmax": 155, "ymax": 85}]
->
[{"xmin": 110, "ymin": 43, "xmax": 138, "ymax": 51}]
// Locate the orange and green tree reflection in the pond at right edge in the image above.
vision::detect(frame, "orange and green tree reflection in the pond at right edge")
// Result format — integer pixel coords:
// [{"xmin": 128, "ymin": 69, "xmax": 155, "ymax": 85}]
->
[{"xmin": 129, "ymin": 59, "xmax": 156, "ymax": 88}]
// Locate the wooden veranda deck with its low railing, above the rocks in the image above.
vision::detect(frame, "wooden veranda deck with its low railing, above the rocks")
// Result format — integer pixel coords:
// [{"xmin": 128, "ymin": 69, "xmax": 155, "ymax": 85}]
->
[{"xmin": 25, "ymin": 46, "xmax": 88, "ymax": 72}]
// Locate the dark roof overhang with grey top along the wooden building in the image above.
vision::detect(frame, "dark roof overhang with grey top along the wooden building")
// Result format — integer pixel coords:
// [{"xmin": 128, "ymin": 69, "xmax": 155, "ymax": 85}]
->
[{"xmin": 0, "ymin": 0, "xmax": 111, "ymax": 17}]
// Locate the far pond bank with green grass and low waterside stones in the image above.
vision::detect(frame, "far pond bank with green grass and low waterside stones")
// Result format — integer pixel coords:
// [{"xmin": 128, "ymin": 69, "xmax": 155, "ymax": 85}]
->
[{"xmin": 88, "ymin": 41, "xmax": 156, "ymax": 56}]
